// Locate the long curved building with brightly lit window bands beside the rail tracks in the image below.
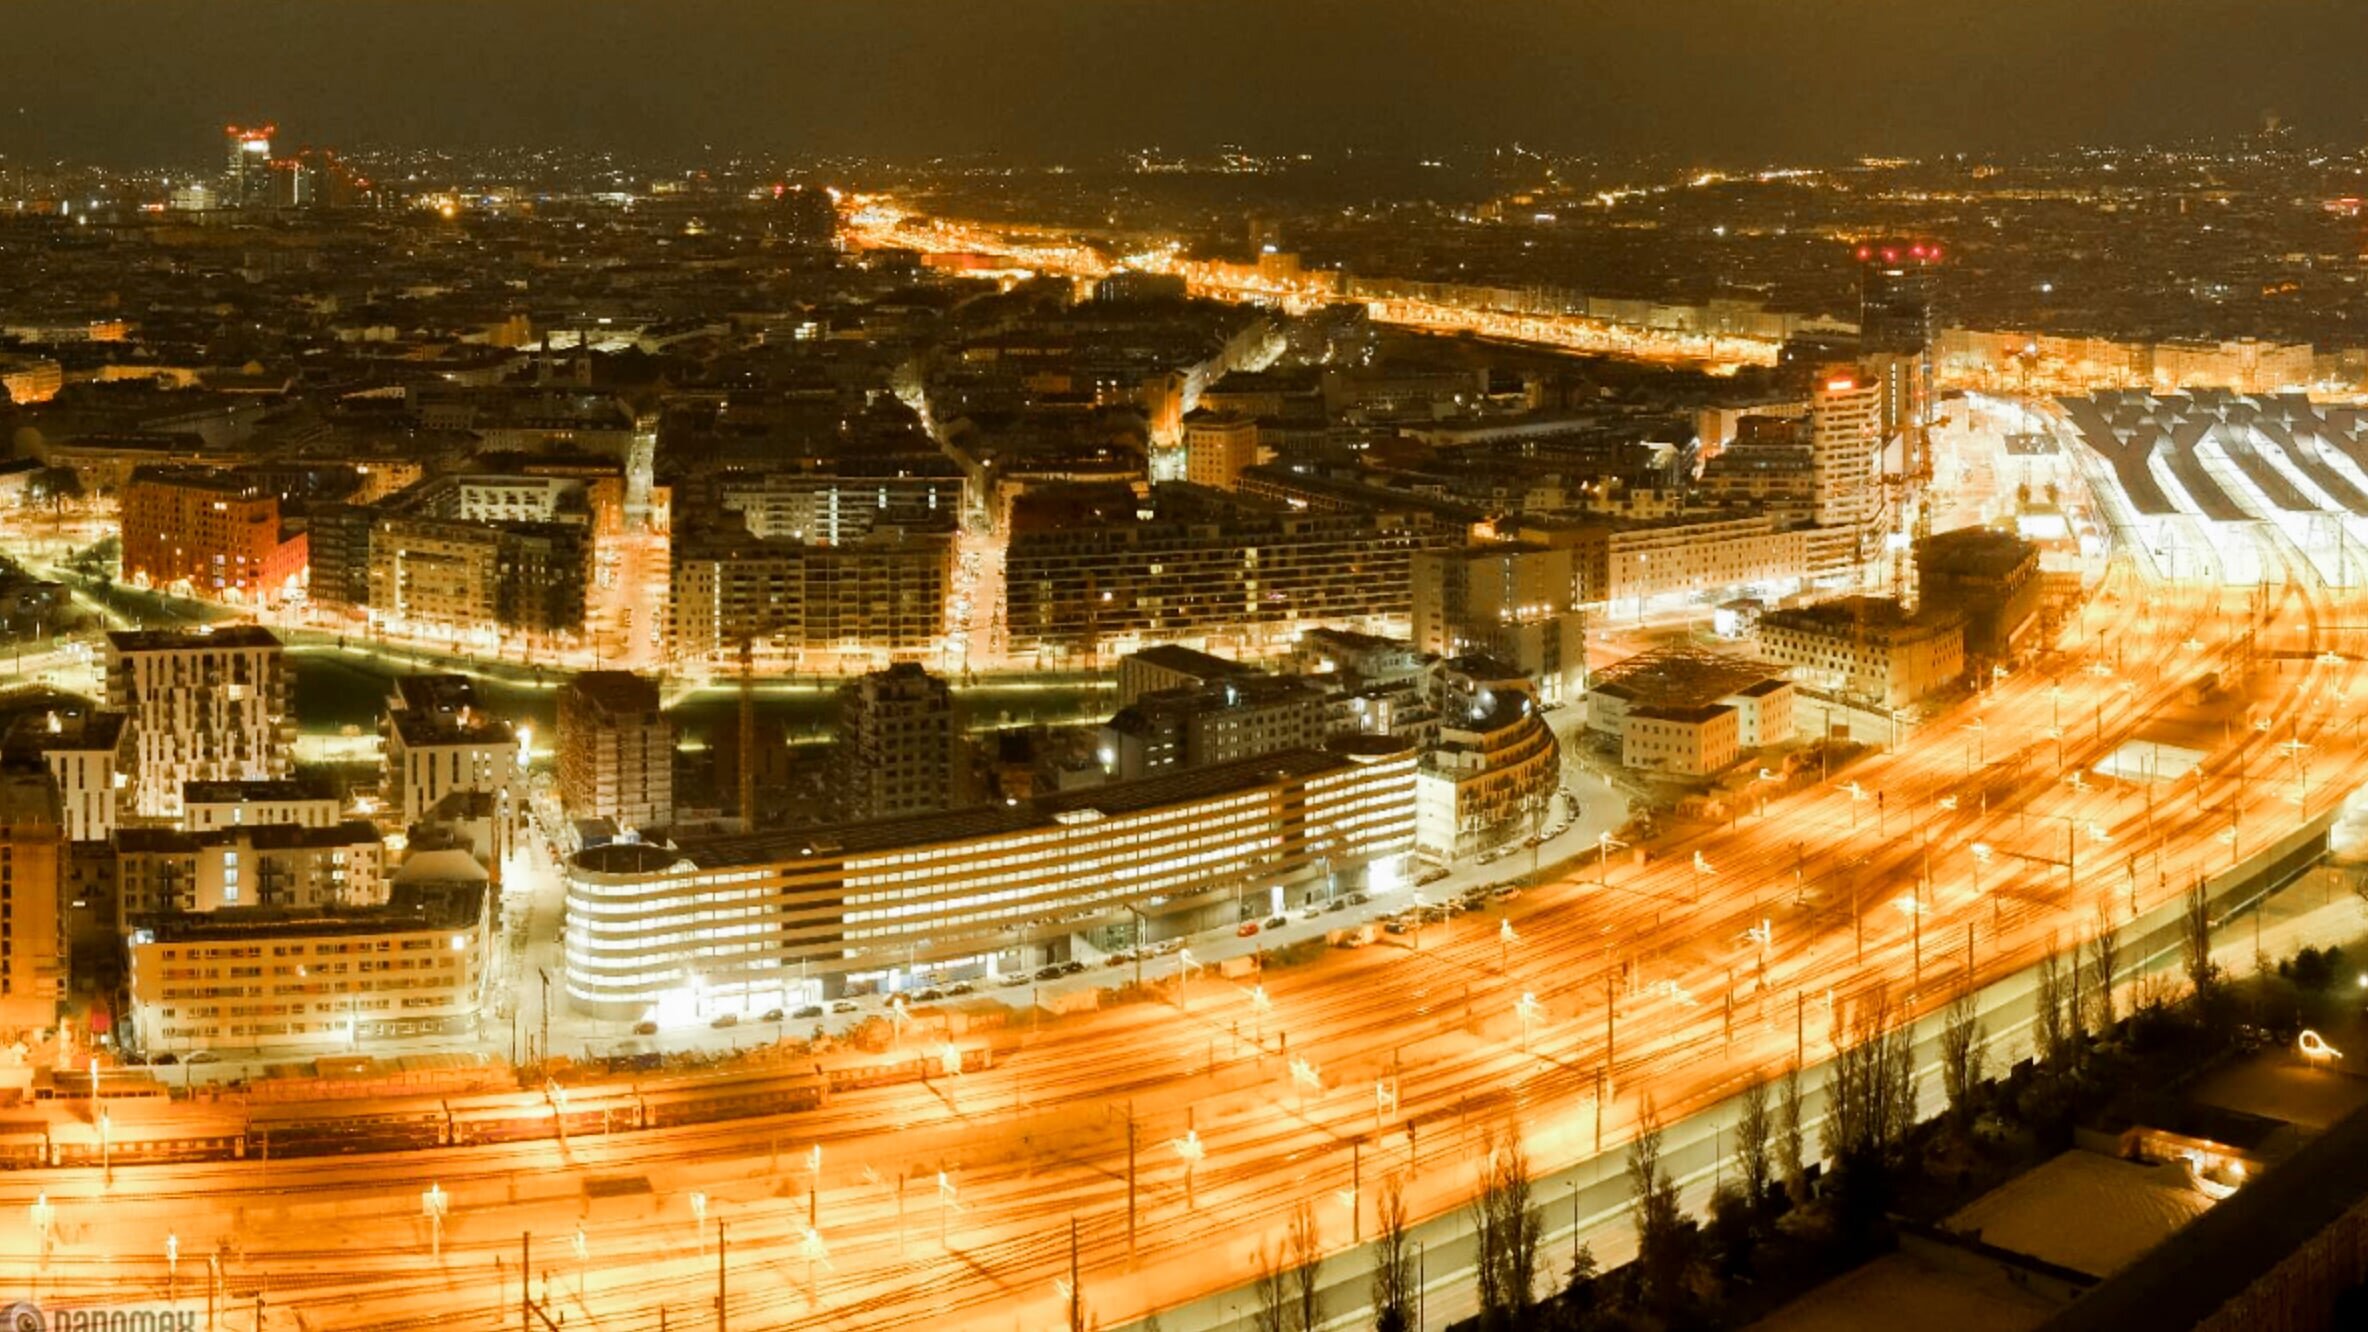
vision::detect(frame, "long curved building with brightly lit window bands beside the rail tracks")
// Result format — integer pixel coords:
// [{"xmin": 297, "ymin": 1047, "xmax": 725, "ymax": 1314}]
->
[{"xmin": 566, "ymin": 737, "xmax": 1414, "ymax": 1019}]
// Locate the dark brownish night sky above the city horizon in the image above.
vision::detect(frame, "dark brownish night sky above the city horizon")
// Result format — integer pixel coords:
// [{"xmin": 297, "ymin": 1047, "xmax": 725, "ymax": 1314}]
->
[{"xmin": 13, "ymin": 0, "xmax": 2368, "ymax": 164}]
